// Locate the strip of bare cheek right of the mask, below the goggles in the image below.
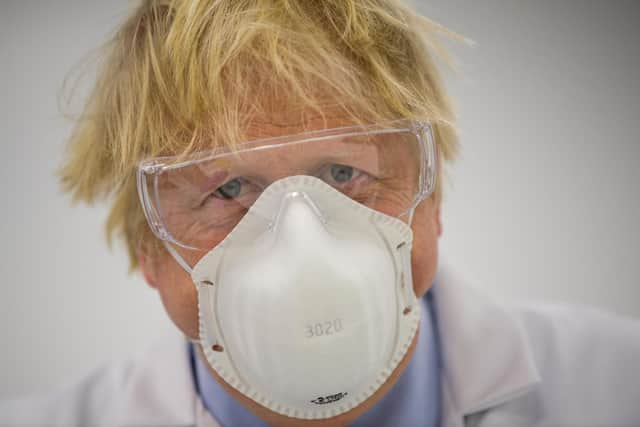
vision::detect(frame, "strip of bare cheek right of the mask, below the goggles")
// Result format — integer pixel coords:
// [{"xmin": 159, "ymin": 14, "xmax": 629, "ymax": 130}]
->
[{"xmin": 411, "ymin": 199, "xmax": 439, "ymax": 298}]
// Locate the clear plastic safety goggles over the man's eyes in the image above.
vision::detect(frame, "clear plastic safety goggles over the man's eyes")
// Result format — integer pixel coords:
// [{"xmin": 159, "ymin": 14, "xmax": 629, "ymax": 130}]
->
[{"xmin": 137, "ymin": 121, "xmax": 436, "ymax": 251}]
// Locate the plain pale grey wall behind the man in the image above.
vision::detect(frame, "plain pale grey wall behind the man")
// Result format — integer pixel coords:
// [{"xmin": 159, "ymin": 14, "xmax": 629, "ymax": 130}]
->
[{"xmin": 0, "ymin": 0, "xmax": 640, "ymax": 397}]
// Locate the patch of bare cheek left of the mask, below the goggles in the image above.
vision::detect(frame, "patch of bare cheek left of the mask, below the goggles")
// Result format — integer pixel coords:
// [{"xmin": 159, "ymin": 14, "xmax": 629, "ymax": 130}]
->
[{"xmin": 156, "ymin": 255, "xmax": 198, "ymax": 339}]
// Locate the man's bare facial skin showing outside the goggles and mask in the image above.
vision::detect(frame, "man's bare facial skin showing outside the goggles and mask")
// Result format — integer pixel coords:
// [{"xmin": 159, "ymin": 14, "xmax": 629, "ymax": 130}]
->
[{"xmin": 139, "ymin": 115, "xmax": 442, "ymax": 427}]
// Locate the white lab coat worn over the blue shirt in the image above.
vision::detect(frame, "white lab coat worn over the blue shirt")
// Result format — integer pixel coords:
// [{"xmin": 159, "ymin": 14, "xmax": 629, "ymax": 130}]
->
[{"xmin": 0, "ymin": 268, "xmax": 640, "ymax": 427}]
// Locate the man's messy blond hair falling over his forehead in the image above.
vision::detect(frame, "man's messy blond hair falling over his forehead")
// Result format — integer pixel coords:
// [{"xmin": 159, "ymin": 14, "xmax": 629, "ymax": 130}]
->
[{"xmin": 60, "ymin": 0, "xmax": 457, "ymax": 269}]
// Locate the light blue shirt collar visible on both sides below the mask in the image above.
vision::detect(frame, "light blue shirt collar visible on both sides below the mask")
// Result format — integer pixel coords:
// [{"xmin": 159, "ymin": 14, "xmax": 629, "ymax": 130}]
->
[{"xmin": 189, "ymin": 289, "xmax": 440, "ymax": 427}]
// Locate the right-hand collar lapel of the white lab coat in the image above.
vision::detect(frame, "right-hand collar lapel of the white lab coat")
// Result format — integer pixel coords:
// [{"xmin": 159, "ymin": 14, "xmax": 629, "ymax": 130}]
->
[{"xmin": 433, "ymin": 265, "xmax": 540, "ymax": 426}]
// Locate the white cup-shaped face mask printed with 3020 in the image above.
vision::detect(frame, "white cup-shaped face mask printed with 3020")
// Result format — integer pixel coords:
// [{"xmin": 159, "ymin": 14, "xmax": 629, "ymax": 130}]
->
[{"xmin": 192, "ymin": 176, "xmax": 420, "ymax": 419}]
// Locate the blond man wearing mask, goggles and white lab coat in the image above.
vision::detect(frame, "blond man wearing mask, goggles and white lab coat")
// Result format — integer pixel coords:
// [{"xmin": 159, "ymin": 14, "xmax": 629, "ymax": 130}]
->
[{"xmin": 0, "ymin": 0, "xmax": 640, "ymax": 427}]
